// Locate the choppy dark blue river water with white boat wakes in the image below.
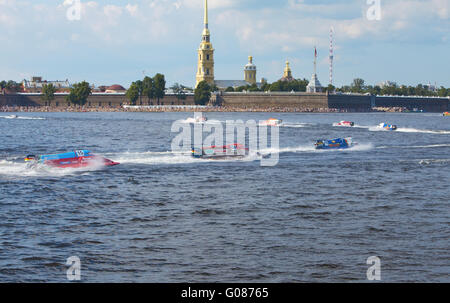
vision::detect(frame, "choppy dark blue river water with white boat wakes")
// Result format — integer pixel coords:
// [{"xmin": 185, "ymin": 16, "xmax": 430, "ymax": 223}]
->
[{"xmin": 0, "ymin": 113, "xmax": 450, "ymax": 282}]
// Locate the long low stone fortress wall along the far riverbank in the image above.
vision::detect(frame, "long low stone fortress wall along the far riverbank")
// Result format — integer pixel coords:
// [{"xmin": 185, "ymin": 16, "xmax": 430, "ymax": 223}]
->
[{"xmin": 0, "ymin": 93, "xmax": 450, "ymax": 112}]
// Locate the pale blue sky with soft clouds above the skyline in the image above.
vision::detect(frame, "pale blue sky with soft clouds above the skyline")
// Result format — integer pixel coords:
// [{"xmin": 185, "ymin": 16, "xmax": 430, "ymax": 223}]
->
[{"xmin": 0, "ymin": 0, "xmax": 450, "ymax": 87}]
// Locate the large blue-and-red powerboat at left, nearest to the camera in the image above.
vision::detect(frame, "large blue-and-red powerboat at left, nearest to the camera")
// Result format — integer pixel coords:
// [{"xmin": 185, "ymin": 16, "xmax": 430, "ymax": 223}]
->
[{"xmin": 25, "ymin": 150, "xmax": 120, "ymax": 168}]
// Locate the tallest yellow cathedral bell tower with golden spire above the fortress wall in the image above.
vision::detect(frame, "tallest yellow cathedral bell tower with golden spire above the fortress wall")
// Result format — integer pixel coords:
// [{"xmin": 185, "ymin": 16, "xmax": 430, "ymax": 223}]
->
[{"xmin": 195, "ymin": 0, "xmax": 214, "ymax": 87}]
